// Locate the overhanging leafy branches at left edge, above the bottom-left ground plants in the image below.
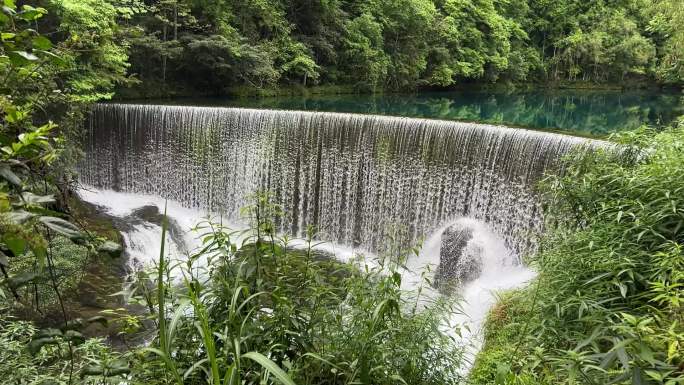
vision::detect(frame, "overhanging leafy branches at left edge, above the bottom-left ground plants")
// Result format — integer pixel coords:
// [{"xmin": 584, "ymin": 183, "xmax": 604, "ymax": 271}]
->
[{"xmin": 0, "ymin": 0, "xmax": 124, "ymax": 299}]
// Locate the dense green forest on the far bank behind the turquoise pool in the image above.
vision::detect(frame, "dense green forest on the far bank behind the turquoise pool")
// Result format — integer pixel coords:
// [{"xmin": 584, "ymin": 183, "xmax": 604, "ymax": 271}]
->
[{"xmin": 14, "ymin": 0, "xmax": 684, "ymax": 96}]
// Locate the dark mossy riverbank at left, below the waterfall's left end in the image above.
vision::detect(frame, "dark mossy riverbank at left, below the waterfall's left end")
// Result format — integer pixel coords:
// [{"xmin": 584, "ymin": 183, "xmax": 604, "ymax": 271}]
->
[{"xmin": 11, "ymin": 193, "xmax": 128, "ymax": 338}]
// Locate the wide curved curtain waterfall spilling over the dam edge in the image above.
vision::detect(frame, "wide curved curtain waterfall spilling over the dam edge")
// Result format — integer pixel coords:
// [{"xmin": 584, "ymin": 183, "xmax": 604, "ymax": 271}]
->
[{"xmin": 79, "ymin": 104, "xmax": 588, "ymax": 254}]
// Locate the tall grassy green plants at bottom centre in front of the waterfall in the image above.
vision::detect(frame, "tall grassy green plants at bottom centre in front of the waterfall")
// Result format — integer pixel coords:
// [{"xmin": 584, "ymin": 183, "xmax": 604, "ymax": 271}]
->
[{"xmin": 115, "ymin": 194, "xmax": 461, "ymax": 385}]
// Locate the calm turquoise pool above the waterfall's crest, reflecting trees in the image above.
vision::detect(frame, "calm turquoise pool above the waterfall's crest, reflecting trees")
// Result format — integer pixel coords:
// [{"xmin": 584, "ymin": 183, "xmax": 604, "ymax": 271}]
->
[{"xmin": 138, "ymin": 90, "xmax": 684, "ymax": 136}]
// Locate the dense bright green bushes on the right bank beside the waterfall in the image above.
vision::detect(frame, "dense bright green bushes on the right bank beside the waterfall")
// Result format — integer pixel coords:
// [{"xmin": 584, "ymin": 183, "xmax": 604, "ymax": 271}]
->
[{"xmin": 476, "ymin": 127, "xmax": 684, "ymax": 384}]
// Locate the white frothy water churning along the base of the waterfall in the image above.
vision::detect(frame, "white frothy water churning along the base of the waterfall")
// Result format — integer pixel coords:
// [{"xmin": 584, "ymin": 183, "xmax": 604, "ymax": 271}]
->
[{"xmin": 79, "ymin": 188, "xmax": 534, "ymax": 375}]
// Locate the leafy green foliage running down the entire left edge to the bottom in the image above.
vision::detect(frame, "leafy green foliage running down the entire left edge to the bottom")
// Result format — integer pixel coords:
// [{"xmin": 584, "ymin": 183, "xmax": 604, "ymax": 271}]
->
[{"xmin": 0, "ymin": 6, "xmax": 126, "ymax": 384}]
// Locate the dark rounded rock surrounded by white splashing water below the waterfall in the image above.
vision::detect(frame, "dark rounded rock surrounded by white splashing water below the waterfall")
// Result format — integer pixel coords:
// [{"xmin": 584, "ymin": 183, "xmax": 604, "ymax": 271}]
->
[{"xmin": 435, "ymin": 223, "xmax": 482, "ymax": 285}]
